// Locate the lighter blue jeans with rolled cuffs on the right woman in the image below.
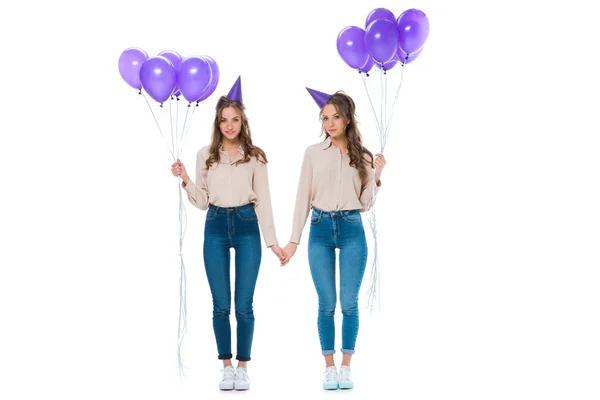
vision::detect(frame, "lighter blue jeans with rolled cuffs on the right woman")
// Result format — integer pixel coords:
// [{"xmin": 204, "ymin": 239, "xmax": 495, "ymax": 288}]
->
[{"xmin": 308, "ymin": 208, "xmax": 368, "ymax": 355}]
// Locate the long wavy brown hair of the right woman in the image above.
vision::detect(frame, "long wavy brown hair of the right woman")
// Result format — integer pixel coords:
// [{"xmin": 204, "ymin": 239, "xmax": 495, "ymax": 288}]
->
[{"xmin": 319, "ymin": 90, "xmax": 374, "ymax": 184}]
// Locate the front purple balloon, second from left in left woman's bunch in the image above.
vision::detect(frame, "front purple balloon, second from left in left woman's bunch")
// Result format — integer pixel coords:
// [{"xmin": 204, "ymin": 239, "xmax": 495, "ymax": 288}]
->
[{"xmin": 140, "ymin": 56, "xmax": 177, "ymax": 105}]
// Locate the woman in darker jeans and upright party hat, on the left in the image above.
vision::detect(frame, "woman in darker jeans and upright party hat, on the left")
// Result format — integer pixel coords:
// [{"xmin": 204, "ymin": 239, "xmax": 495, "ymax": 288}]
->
[{"xmin": 171, "ymin": 78, "xmax": 287, "ymax": 390}]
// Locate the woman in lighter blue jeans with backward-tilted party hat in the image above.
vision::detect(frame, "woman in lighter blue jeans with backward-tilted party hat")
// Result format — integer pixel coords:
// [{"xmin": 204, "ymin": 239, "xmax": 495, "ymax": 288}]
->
[{"xmin": 284, "ymin": 89, "xmax": 385, "ymax": 390}]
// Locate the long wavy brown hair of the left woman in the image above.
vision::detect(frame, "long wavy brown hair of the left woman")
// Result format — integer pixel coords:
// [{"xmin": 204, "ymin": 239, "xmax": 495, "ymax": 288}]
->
[{"xmin": 206, "ymin": 96, "xmax": 267, "ymax": 169}]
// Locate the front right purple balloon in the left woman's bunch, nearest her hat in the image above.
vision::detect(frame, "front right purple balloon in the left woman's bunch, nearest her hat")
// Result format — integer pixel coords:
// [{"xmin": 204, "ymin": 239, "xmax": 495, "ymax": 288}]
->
[{"xmin": 177, "ymin": 56, "xmax": 212, "ymax": 103}]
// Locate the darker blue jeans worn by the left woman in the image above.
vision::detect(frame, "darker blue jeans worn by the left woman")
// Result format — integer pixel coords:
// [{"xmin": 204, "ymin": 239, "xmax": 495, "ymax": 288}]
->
[{"xmin": 204, "ymin": 204, "xmax": 262, "ymax": 361}]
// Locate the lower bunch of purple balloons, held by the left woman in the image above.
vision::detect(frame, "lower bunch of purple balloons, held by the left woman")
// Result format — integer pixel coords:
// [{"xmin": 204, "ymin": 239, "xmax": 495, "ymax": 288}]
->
[{"xmin": 119, "ymin": 47, "xmax": 219, "ymax": 106}]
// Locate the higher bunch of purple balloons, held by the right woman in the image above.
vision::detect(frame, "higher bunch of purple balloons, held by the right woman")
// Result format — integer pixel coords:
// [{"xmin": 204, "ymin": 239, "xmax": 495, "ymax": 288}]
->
[{"xmin": 337, "ymin": 8, "xmax": 429, "ymax": 73}]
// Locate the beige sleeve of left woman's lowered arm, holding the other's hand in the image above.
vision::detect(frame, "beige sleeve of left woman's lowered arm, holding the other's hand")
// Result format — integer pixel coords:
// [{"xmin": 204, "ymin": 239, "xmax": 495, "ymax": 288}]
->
[{"xmin": 252, "ymin": 161, "xmax": 277, "ymax": 247}]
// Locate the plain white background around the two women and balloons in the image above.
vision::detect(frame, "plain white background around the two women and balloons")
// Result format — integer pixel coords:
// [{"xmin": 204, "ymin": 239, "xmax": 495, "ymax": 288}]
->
[{"xmin": 0, "ymin": 0, "xmax": 600, "ymax": 399}]
